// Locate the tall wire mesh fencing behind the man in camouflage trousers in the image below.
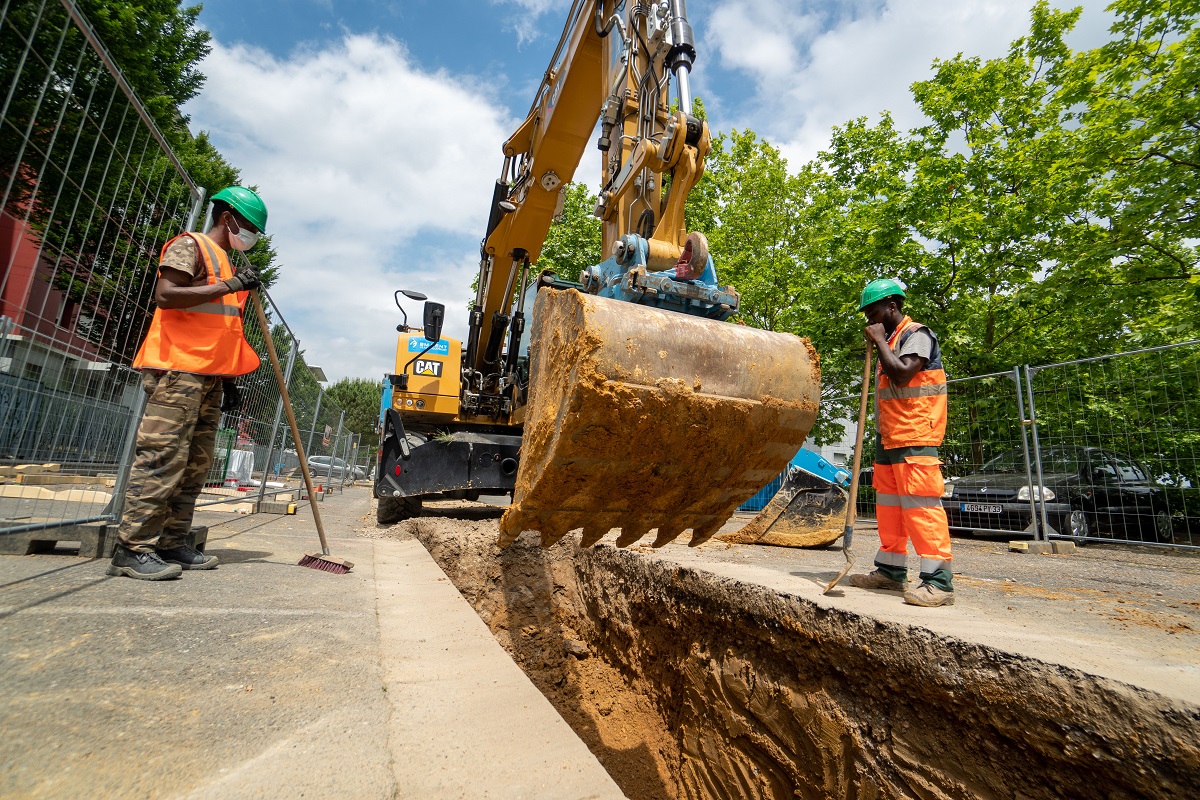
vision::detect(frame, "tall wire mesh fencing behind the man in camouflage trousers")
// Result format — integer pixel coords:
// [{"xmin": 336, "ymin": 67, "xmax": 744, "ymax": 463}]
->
[{"xmin": 0, "ymin": 0, "xmax": 354, "ymax": 533}]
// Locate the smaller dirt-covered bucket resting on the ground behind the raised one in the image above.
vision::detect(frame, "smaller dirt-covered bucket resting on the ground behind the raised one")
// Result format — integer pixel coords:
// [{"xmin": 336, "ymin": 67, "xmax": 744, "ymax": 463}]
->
[{"xmin": 718, "ymin": 467, "xmax": 847, "ymax": 547}]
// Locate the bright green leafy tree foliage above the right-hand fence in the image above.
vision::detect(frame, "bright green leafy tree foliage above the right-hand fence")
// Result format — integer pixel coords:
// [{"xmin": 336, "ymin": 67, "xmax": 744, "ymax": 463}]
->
[{"xmin": 688, "ymin": 0, "xmax": 1200, "ymax": 450}]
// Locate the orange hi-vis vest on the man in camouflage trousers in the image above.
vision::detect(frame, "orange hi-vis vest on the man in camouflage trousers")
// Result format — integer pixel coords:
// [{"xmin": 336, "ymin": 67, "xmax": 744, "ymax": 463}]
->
[{"xmin": 133, "ymin": 233, "xmax": 260, "ymax": 377}]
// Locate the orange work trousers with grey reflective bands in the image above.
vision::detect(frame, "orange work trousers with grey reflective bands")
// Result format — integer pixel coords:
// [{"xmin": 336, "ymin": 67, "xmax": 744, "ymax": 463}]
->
[{"xmin": 871, "ymin": 456, "xmax": 950, "ymax": 573}]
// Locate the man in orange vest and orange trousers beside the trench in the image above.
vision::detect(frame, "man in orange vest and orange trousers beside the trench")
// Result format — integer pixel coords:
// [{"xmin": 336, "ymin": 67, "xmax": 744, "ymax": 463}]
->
[{"xmin": 850, "ymin": 278, "xmax": 954, "ymax": 606}]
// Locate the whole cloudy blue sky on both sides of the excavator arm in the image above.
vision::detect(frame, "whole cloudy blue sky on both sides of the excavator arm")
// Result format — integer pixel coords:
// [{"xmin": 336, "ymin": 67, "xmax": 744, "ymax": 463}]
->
[{"xmin": 185, "ymin": 0, "xmax": 1108, "ymax": 380}]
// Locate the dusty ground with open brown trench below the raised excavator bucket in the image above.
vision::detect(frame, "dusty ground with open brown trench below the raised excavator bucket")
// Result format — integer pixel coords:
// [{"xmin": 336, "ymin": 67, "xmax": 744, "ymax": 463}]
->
[{"xmin": 371, "ymin": 504, "xmax": 1200, "ymax": 799}]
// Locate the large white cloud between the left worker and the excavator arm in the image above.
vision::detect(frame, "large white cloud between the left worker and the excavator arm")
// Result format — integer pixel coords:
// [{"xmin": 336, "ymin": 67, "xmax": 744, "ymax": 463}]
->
[{"xmin": 185, "ymin": 35, "xmax": 515, "ymax": 380}]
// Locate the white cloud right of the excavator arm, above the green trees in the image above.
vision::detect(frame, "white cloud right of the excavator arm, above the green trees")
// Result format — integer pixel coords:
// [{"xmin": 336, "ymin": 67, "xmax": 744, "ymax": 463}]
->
[{"xmin": 704, "ymin": 0, "xmax": 1108, "ymax": 166}]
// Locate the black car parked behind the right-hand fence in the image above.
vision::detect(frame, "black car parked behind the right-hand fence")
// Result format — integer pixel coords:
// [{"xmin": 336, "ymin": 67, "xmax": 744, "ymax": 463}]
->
[{"xmin": 942, "ymin": 447, "xmax": 1171, "ymax": 542}]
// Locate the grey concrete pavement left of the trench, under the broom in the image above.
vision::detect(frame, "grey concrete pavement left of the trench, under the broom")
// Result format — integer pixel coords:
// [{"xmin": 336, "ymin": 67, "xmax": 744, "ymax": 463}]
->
[{"xmin": 0, "ymin": 488, "xmax": 622, "ymax": 798}]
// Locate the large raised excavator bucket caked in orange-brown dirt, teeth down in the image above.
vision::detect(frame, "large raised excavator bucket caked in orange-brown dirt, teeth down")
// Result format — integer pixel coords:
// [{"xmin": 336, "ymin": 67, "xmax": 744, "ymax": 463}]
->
[{"xmin": 500, "ymin": 289, "xmax": 821, "ymax": 547}]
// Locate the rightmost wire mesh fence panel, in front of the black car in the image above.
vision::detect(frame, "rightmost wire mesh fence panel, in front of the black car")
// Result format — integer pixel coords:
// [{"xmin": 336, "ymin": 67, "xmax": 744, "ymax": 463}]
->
[{"xmin": 1028, "ymin": 342, "xmax": 1200, "ymax": 547}]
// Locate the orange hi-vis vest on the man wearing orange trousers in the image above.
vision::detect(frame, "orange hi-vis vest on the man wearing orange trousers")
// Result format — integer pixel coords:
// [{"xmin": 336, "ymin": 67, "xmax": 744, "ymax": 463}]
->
[{"xmin": 875, "ymin": 317, "xmax": 947, "ymax": 450}]
